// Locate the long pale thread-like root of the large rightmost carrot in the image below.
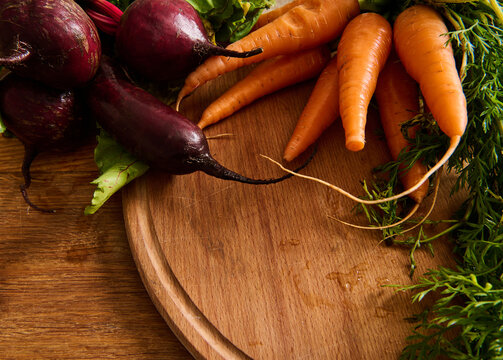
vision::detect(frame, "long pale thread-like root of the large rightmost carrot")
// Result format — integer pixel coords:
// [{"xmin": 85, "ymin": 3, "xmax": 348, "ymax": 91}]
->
[{"xmin": 261, "ymin": 136, "xmax": 461, "ymax": 205}]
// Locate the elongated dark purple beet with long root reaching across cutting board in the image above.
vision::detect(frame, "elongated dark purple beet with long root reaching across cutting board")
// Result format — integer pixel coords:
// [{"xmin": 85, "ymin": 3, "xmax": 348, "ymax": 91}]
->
[{"xmin": 85, "ymin": 57, "xmax": 309, "ymax": 184}]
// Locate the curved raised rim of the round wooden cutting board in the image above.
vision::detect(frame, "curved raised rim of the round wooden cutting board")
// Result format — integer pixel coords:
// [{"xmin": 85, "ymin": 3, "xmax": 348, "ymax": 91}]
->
[{"xmin": 123, "ymin": 186, "xmax": 250, "ymax": 359}]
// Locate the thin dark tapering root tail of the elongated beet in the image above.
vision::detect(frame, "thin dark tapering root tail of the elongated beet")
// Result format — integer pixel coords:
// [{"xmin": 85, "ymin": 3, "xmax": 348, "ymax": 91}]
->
[{"xmin": 201, "ymin": 148, "xmax": 317, "ymax": 185}]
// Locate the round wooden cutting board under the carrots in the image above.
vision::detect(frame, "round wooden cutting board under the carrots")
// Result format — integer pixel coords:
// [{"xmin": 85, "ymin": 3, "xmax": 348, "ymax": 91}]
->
[{"xmin": 123, "ymin": 61, "xmax": 466, "ymax": 359}]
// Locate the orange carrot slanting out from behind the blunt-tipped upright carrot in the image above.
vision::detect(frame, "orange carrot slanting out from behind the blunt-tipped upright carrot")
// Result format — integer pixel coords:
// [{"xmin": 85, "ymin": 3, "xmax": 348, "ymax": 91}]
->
[{"xmin": 283, "ymin": 57, "xmax": 339, "ymax": 161}]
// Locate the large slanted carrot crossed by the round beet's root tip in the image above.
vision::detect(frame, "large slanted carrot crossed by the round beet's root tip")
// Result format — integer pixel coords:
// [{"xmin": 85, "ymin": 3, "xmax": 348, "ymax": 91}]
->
[{"xmin": 176, "ymin": 0, "xmax": 360, "ymax": 109}]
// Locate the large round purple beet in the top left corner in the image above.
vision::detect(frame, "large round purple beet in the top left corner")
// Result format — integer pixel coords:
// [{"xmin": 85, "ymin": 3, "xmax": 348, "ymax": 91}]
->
[{"xmin": 0, "ymin": 0, "xmax": 101, "ymax": 89}]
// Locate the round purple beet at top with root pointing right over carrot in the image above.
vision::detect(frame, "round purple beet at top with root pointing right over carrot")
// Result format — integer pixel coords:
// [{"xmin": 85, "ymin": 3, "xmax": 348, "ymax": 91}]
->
[{"xmin": 116, "ymin": 0, "xmax": 262, "ymax": 82}]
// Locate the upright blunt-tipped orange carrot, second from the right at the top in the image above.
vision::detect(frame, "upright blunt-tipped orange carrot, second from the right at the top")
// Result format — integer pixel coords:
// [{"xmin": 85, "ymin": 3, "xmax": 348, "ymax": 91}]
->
[{"xmin": 337, "ymin": 13, "xmax": 392, "ymax": 151}]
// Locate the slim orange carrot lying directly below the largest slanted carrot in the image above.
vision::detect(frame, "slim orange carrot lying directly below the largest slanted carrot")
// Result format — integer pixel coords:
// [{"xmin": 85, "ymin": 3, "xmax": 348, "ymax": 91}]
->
[{"xmin": 197, "ymin": 45, "xmax": 330, "ymax": 129}]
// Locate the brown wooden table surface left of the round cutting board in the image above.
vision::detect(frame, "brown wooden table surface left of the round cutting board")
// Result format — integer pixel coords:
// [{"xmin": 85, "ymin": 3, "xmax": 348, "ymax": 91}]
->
[{"xmin": 0, "ymin": 137, "xmax": 191, "ymax": 360}]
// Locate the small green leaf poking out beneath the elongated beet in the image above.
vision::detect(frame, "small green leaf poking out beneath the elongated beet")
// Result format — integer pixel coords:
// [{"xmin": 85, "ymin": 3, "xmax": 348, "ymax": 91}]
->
[{"xmin": 84, "ymin": 130, "xmax": 149, "ymax": 215}]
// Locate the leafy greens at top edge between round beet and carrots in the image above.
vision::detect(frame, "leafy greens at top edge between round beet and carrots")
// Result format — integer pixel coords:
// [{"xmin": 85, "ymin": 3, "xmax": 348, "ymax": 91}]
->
[{"xmin": 187, "ymin": 0, "xmax": 275, "ymax": 43}]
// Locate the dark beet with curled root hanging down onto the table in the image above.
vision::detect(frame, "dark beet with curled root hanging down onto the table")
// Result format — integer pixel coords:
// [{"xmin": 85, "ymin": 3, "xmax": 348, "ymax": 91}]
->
[{"xmin": 0, "ymin": 74, "xmax": 88, "ymax": 211}]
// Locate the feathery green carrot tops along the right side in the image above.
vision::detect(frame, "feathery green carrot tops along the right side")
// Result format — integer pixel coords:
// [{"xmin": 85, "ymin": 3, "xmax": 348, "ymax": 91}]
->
[{"xmin": 356, "ymin": 0, "xmax": 503, "ymax": 359}]
